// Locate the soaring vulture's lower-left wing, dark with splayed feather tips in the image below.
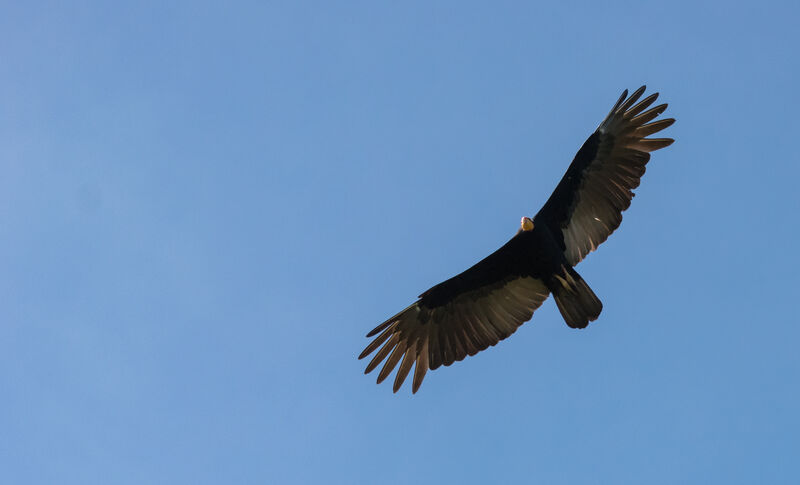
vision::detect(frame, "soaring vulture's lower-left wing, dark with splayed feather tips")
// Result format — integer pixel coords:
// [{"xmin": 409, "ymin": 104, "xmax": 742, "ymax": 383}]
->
[{"xmin": 358, "ymin": 238, "xmax": 549, "ymax": 393}]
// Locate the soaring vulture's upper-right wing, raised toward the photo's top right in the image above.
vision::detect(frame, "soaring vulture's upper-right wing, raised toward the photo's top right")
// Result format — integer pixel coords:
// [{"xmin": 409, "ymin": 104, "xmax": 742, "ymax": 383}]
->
[{"xmin": 534, "ymin": 86, "xmax": 675, "ymax": 266}]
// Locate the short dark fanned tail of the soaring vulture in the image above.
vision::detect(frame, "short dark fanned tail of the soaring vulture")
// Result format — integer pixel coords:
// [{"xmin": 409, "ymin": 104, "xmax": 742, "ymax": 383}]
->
[{"xmin": 550, "ymin": 266, "xmax": 603, "ymax": 328}]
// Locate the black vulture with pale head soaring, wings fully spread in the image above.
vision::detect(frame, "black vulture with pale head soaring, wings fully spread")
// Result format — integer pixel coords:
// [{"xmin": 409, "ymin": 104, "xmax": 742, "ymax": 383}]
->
[{"xmin": 358, "ymin": 86, "xmax": 675, "ymax": 393}]
